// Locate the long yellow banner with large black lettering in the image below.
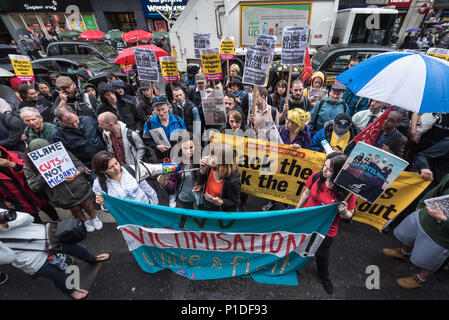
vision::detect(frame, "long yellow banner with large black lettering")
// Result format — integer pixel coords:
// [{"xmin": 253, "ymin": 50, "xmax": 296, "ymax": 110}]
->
[{"xmin": 213, "ymin": 134, "xmax": 430, "ymax": 231}]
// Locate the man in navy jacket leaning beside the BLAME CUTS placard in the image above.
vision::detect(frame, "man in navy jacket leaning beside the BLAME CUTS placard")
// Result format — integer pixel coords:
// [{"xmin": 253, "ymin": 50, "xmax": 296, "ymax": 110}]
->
[{"xmin": 52, "ymin": 106, "xmax": 106, "ymax": 183}]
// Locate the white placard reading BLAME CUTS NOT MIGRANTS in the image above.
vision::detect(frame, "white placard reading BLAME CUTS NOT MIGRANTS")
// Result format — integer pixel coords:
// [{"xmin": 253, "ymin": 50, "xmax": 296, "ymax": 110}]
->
[{"xmin": 28, "ymin": 141, "xmax": 78, "ymax": 188}]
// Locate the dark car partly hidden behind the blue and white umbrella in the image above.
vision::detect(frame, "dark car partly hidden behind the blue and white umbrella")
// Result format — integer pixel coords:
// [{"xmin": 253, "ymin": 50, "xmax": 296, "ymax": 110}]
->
[{"xmin": 311, "ymin": 44, "xmax": 396, "ymax": 86}]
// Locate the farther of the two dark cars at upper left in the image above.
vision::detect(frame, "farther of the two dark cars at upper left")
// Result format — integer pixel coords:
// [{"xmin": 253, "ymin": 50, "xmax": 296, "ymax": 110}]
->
[{"xmin": 47, "ymin": 41, "xmax": 118, "ymax": 63}]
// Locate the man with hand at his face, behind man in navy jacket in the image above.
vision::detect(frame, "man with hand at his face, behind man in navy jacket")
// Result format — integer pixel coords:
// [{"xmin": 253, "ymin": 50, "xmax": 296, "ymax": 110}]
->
[{"xmin": 51, "ymin": 76, "xmax": 97, "ymax": 119}]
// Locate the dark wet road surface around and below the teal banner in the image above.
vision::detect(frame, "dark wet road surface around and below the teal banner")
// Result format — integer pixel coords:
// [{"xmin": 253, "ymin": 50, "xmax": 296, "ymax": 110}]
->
[{"xmin": 0, "ymin": 196, "xmax": 449, "ymax": 302}]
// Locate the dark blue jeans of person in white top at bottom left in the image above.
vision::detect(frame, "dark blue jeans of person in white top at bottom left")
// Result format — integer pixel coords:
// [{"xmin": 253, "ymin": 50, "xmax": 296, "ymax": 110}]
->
[{"xmin": 34, "ymin": 243, "xmax": 96, "ymax": 294}]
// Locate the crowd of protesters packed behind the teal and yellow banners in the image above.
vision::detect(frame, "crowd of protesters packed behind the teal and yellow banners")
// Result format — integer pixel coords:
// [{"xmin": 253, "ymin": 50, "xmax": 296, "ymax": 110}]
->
[{"xmin": 0, "ymin": 57, "xmax": 449, "ymax": 298}]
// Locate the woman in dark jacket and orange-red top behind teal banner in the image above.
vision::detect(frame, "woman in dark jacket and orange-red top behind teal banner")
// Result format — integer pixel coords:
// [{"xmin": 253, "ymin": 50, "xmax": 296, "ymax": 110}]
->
[{"xmin": 193, "ymin": 143, "xmax": 241, "ymax": 212}]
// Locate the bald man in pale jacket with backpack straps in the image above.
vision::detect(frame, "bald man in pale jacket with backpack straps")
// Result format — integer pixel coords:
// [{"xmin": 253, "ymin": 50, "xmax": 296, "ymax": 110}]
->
[{"xmin": 98, "ymin": 111, "xmax": 146, "ymax": 165}]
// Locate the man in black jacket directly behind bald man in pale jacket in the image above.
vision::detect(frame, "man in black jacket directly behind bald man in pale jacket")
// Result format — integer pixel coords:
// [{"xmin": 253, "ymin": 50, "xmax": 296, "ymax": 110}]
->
[{"xmin": 98, "ymin": 82, "xmax": 143, "ymax": 133}]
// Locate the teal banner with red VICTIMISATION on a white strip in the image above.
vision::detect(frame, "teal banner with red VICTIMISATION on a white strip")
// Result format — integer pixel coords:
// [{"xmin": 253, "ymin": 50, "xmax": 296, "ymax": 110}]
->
[{"xmin": 104, "ymin": 195, "xmax": 338, "ymax": 285}]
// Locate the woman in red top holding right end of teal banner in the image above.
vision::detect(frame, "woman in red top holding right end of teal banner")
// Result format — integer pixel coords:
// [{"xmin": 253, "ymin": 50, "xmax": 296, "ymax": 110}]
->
[{"xmin": 297, "ymin": 152, "xmax": 356, "ymax": 294}]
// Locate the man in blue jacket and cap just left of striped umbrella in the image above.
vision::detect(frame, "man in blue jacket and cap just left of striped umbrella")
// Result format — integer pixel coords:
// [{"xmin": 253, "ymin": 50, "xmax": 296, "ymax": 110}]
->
[{"xmin": 310, "ymin": 82, "xmax": 348, "ymax": 136}]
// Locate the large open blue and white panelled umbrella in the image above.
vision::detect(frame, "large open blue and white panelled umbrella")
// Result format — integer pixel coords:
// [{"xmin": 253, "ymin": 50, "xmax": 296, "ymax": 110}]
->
[{"xmin": 336, "ymin": 52, "xmax": 449, "ymax": 113}]
